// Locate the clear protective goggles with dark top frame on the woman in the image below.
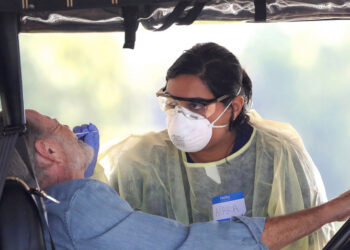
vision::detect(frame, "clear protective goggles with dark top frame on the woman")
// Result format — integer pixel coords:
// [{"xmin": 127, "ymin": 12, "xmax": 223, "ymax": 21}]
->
[{"xmin": 156, "ymin": 88, "xmax": 231, "ymax": 119}]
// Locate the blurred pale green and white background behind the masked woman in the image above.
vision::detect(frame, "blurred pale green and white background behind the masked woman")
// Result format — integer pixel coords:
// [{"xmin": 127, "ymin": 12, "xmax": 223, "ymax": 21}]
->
[{"xmin": 20, "ymin": 21, "xmax": 350, "ymax": 203}]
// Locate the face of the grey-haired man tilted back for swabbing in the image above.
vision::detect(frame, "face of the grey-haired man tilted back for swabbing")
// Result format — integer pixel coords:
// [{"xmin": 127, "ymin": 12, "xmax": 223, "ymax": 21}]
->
[{"xmin": 26, "ymin": 110, "xmax": 93, "ymax": 170}]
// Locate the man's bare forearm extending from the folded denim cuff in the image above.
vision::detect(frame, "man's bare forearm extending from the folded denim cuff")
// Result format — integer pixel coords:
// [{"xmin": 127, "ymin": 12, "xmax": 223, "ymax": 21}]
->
[{"xmin": 261, "ymin": 191, "xmax": 350, "ymax": 249}]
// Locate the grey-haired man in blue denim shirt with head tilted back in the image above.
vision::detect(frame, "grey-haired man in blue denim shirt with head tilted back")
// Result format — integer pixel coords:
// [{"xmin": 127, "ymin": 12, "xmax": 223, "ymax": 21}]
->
[{"xmin": 15, "ymin": 110, "xmax": 350, "ymax": 249}]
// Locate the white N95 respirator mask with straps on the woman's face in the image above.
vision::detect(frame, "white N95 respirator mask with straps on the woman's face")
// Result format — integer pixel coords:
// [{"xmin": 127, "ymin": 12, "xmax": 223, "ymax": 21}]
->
[{"xmin": 166, "ymin": 103, "xmax": 231, "ymax": 153}]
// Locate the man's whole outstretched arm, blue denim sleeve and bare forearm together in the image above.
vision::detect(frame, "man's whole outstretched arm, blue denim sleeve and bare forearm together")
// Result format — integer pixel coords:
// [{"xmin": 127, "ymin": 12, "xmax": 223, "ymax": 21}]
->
[{"xmin": 47, "ymin": 180, "xmax": 350, "ymax": 250}]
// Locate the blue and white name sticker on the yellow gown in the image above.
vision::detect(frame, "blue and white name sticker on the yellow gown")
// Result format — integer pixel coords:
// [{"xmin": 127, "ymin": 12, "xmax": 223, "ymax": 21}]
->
[{"xmin": 212, "ymin": 192, "xmax": 247, "ymax": 221}]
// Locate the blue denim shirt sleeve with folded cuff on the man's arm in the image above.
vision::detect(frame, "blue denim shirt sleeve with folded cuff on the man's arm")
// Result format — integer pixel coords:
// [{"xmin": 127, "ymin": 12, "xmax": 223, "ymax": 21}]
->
[{"xmin": 59, "ymin": 181, "xmax": 267, "ymax": 250}]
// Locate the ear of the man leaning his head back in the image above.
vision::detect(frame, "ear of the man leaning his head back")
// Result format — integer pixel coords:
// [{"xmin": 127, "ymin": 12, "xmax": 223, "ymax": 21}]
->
[{"xmin": 34, "ymin": 139, "xmax": 62, "ymax": 163}]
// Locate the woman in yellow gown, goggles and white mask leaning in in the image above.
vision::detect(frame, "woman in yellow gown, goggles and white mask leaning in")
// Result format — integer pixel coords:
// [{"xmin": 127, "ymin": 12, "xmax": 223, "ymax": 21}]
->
[{"xmin": 100, "ymin": 43, "xmax": 333, "ymax": 249}]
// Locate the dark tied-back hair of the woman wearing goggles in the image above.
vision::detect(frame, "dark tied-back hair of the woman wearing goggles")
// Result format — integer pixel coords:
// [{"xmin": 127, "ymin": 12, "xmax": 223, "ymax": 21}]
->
[{"xmin": 166, "ymin": 43, "xmax": 252, "ymax": 131}]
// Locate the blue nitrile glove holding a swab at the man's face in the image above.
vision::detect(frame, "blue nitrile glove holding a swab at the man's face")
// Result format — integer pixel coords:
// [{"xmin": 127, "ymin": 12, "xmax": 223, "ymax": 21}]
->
[{"xmin": 73, "ymin": 123, "xmax": 100, "ymax": 178}]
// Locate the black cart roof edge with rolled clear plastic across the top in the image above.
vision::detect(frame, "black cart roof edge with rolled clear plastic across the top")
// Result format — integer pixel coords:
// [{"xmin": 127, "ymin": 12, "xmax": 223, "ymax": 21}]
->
[{"xmin": 0, "ymin": 0, "xmax": 350, "ymax": 32}]
